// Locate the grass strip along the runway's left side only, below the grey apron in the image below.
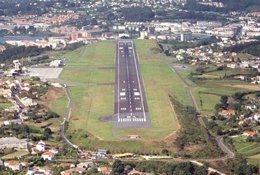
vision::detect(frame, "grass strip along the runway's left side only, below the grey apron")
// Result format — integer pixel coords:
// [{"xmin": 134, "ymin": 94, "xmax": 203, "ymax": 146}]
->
[{"xmin": 60, "ymin": 42, "xmax": 115, "ymax": 139}]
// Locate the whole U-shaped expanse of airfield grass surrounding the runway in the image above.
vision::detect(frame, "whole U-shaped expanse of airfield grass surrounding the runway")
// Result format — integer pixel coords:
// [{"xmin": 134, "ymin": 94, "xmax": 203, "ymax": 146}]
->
[{"xmin": 53, "ymin": 40, "xmax": 190, "ymax": 152}]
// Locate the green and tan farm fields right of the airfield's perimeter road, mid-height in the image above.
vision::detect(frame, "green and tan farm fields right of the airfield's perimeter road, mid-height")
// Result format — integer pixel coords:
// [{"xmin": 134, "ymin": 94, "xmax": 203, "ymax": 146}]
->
[{"xmin": 180, "ymin": 65, "xmax": 260, "ymax": 115}]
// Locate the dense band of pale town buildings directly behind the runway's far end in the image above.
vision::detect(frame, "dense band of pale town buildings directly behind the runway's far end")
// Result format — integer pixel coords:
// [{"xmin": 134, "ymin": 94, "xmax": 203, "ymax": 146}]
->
[{"xmin": 1, "ymin": 17, "xmax": 260, "ymax": 49}]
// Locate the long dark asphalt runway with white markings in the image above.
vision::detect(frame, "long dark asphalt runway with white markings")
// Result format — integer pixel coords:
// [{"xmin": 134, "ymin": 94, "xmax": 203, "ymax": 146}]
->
[{"xmin": 114, "ymin": 40, "xmax": 150, "ymax": 128}]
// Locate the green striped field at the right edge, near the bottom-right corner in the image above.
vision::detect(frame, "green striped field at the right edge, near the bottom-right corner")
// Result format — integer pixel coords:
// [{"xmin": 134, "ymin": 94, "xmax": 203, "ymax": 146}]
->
[{"xmin": 233, "ymin": 136, "xmax": 260, "ymax": 165}]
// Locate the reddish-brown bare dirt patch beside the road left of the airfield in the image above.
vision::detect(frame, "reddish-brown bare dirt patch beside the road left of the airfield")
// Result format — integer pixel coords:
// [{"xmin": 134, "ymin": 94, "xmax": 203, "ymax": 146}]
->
[{"xmin": 41, "ymin": 87, "xmax": 66, "ymax": 106}]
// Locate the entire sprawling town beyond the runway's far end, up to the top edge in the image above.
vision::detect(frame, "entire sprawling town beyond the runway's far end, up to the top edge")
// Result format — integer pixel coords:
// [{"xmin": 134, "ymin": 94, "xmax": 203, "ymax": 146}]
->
[{"xmin": 0, "ymin": 0, "xmax": 260, "ymax": 52}]
